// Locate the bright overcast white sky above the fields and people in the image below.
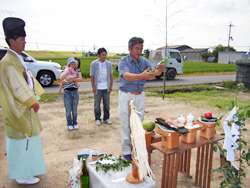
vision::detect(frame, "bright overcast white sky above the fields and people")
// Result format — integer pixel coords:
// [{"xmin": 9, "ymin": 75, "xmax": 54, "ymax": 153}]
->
[{"xmin": 0, "ymin": 0, "xmax": 250, "ymax": 53}]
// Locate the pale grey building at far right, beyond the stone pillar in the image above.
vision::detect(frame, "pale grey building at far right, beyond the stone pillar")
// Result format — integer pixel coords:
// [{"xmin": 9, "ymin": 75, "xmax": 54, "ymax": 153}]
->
[{"xmin": 218, "ymin": 51, "xmax": 250, "ymax": 64}]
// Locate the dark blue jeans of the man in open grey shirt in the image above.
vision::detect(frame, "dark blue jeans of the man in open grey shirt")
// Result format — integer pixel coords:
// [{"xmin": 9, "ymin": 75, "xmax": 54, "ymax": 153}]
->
[{"xmin": 94, "ymin": 89, "xmax": 110, "ymax": 121}]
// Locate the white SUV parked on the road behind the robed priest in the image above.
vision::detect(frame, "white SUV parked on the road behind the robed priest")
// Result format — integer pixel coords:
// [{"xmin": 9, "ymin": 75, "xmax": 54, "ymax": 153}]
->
[{"xmin": 0, "ymin": 47, "xmax": 62, "ymax": 87}]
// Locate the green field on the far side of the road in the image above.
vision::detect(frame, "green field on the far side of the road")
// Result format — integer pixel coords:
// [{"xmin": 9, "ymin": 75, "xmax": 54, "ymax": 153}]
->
[{"xmin": 27, "ymin": 51, "xmax": 236, "ymax": 79}]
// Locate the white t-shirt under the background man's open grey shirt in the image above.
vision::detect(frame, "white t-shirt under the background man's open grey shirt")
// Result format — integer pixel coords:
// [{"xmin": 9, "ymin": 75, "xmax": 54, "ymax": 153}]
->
[{"xmin": 97, "ymin": 61, "xmax": 108, "ymax": 90}]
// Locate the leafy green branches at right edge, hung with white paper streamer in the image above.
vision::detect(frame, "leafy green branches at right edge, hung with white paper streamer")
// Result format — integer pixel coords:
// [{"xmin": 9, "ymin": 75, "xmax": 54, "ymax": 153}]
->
[{"xmin": 212, "ymin": 83, "xmax": 250, "ymax": 188}]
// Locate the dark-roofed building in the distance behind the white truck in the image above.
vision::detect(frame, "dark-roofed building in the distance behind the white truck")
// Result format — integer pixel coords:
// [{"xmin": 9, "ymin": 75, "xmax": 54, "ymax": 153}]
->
[{"xmin": 157, "ymin": 45, "xmax": 208, "ymax": 62}]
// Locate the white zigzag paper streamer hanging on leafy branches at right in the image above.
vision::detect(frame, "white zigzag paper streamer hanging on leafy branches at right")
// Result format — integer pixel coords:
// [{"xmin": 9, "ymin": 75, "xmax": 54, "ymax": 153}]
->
[{"xmin": 223, "ymin": 107, "xmax": 240, "ymax": 170}]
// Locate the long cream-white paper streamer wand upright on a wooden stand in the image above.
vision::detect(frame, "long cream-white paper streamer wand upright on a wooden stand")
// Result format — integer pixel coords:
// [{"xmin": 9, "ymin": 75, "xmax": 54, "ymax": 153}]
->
[{"xmin": 130, "ymin": 100, "xmax": 155, "ymax": 180}]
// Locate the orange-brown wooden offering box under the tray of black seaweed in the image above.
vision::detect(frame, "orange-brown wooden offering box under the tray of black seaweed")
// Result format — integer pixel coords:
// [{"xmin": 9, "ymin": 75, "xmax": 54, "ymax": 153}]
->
[{"xmin": 157, "ymin": 127, "xmax": 180, "ymax": 149}]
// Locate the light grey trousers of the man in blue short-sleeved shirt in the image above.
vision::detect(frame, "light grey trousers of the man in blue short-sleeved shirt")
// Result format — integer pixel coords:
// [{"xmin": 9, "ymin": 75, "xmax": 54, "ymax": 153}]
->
[{"xmin": 118, "ymin": 91, "xmax": 145, "ymax": 155}]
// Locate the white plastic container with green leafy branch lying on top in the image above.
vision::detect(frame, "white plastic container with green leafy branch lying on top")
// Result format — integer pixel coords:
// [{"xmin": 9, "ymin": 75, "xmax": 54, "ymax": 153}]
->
[{"xmin": 88, "ymin": 163, "xmax": 156, "ymax": 188}]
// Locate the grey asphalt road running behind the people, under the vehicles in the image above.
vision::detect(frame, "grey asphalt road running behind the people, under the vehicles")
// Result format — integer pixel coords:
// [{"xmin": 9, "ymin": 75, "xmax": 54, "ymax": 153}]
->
[{"xmin": 44, "ymin": 74, "xmax": 236, "ymax": 93}]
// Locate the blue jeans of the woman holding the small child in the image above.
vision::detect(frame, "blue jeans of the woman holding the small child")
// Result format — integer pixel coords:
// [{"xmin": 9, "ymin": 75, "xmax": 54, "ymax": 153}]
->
[{"xmin": 63, "ymin": 89, "xmax": 79, "ymax": 126}]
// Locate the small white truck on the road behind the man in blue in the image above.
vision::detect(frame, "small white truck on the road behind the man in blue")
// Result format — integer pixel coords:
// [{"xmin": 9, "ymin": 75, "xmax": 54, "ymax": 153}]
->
[{"xmin": 109, "ymin": 49, "xmax": 183, "ymax": 80}]
